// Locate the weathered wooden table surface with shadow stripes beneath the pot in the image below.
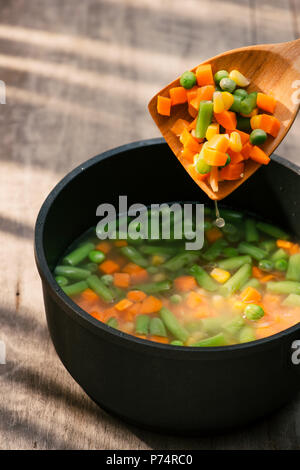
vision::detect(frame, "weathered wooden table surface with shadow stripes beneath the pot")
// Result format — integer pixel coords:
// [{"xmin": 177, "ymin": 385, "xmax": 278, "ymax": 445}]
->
[{"xmin": 0, "ymin": 0, "xmax": 300, "ymax": 450}]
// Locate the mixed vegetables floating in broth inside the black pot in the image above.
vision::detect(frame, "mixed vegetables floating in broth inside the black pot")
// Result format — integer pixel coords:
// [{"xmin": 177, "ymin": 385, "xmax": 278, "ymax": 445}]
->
[{"xmin": 55, "ymin": 207, "xmax": 300, "ymax": 347}]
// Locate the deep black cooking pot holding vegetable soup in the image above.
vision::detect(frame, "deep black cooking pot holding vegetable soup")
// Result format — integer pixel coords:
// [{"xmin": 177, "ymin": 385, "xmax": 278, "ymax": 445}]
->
[{"xmin": 35, "ymin": 139, "xmax": 300, "ymax": 434}]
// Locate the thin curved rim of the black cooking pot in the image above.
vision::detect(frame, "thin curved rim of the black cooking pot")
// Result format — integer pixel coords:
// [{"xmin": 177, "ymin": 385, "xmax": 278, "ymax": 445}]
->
[{"xmin": 34, "ymin": 138, "xmax": 300, "ymax": 360}]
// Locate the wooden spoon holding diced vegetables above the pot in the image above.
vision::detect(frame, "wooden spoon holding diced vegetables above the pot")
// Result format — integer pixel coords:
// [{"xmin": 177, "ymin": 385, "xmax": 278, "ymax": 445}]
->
[{"xmin": 148, "ymin": 39, "xmax": 300, "ymax": 200}]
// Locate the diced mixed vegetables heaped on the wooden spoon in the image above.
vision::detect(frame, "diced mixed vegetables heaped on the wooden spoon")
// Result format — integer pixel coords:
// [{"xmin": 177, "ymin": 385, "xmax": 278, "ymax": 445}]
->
[{"xmin": 157, "ymin": 64, "xmax": 280, "ymax": 192}]
